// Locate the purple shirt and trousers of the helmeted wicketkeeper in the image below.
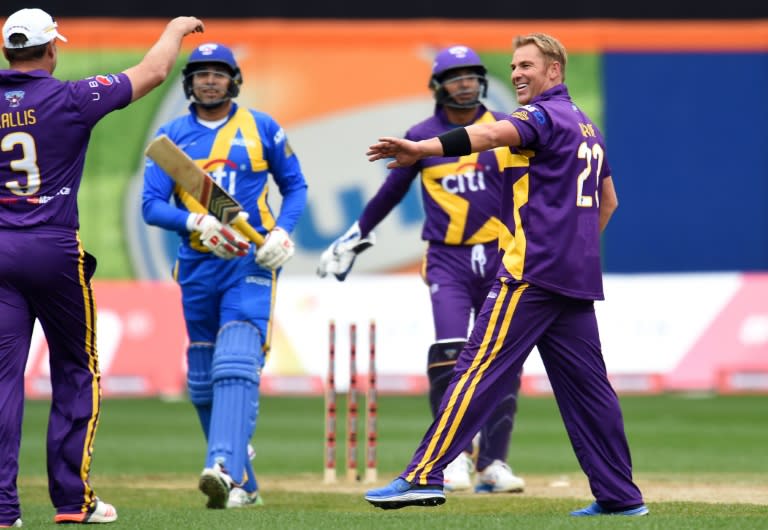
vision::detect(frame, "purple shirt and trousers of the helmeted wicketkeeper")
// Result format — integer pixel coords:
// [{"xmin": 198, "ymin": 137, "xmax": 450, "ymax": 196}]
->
[{"xmin": 359, "ymin": 105, "xmax": 519, "ymax": 469}]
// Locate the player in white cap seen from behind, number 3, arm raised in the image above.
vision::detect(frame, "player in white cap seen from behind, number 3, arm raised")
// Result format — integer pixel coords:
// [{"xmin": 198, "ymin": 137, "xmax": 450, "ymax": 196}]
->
[{"xmin": 0, "ymin": 9, "xmax": 203, "ymax": 527}]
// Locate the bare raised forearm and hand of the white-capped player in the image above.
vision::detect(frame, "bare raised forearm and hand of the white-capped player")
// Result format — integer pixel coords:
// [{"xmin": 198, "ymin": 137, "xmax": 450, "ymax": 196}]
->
[{"xmin": 124, "ymin": 17, "xmax": 203, "ymax": 102}]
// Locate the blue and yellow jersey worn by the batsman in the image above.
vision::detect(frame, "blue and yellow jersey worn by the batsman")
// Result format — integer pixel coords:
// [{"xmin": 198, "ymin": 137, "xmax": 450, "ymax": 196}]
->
[{"xmin": 142, "ymin": 104, "xmax": 307, "ymax": 256}]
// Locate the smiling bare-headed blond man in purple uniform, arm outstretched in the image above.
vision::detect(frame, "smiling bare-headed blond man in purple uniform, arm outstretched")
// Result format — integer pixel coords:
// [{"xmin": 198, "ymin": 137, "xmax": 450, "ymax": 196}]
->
[{"xmin": 365, "ymin": 33, "xmax": 648, "ymax": 516}]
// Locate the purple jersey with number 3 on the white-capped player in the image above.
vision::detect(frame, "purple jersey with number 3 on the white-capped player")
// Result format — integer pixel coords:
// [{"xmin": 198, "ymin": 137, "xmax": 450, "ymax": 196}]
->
[{"xmin": 0, "ymin": 70, "xmax": 132, "ymax": 228}]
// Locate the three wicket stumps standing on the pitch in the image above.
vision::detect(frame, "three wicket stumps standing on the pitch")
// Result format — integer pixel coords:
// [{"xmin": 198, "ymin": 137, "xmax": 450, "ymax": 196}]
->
[{"xmin": 323, "ymin": 320, "xmax": 378, "ymax": 484}]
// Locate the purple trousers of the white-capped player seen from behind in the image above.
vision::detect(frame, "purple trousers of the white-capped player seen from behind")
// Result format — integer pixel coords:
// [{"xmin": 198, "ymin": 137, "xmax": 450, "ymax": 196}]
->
[{"xmin": 0, "ymin": 227, "xmax": 101, "ymax": 524}]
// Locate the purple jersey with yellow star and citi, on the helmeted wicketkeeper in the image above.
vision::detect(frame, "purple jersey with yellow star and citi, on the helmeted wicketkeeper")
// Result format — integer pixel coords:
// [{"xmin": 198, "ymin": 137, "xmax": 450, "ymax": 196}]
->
[{"xmin": 359, "ymin": 105, "xmax": 510, "ymax": 245}]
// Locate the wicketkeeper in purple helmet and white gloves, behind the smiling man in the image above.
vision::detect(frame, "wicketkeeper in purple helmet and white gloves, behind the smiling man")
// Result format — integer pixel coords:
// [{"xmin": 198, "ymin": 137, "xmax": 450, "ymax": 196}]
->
[{"xmin": 318, "ymin": 45, "xmax": 525, "ymax": 493}]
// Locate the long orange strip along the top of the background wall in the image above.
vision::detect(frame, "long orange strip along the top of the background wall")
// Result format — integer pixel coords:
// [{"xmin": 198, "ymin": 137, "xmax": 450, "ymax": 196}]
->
[{"xmin": 51, "ymin": 18, "xmax": 768, "ymax": 51}]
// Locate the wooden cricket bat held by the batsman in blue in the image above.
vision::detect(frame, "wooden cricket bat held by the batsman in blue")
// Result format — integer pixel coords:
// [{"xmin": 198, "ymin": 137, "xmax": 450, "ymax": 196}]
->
[{"xmin": 144, "ymin": 134, "xmax": 264, "ymax": 247}]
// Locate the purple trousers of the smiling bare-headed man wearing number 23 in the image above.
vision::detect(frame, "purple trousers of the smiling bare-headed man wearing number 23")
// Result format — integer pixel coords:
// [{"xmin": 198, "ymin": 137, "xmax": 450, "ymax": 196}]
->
[{"xmin": 400, "ymin": 278, "xmax": 643, "ymax": 510}]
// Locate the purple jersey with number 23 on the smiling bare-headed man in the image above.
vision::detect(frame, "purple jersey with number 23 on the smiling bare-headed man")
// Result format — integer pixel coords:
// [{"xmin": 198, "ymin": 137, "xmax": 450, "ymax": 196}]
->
[{"xmin": 500, "ymin": 85, "xmax": 611, "ymax": 300}]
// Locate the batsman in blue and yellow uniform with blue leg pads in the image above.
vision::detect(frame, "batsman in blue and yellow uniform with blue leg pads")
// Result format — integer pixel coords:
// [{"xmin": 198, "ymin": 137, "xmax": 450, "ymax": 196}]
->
[{"xmin": 142, "ymin": 43, "xmax": 307, "ymax": 508}]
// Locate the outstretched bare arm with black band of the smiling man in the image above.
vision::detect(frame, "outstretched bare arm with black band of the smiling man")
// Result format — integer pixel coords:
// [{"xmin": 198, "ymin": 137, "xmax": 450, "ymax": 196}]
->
[{"xmin": 366, "ymin": 120, "xmax": 520, "ymax": 169}]
